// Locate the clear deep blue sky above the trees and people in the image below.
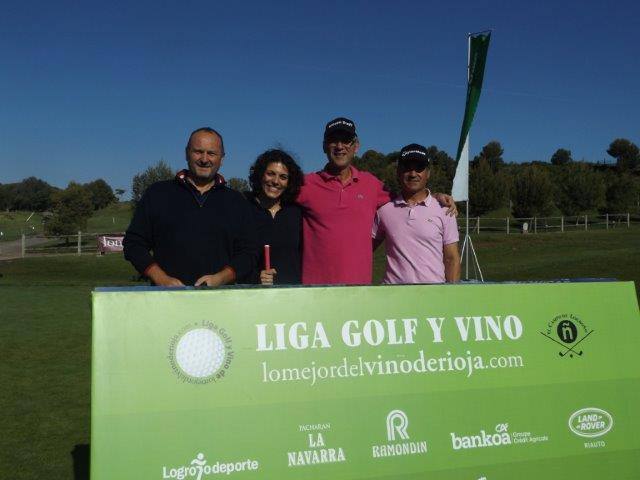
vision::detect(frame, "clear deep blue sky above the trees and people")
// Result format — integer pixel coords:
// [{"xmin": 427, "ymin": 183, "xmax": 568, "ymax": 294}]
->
[{"xmin": 0, "ymin": 1, "xmax": 640, "ymax": 195}]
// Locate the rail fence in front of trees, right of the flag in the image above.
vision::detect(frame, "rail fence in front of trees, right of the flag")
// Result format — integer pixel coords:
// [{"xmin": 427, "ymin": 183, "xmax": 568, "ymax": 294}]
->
[{"xmin": 458, "ymin": 213, "xmax": 640, "ymax": 235}]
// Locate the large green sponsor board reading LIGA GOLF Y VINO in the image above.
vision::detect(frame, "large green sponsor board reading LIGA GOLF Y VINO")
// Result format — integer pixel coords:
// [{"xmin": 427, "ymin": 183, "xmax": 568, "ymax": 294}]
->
[{"xmin": 91, "ymin": 282, "xmax": 640, "ymax": 480}]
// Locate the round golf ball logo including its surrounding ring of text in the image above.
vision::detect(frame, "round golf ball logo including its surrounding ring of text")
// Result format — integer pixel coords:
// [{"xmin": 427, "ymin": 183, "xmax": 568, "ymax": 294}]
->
[{"xmin": 169, "ymin": 320, "xmax": 234, "ymax": 383}]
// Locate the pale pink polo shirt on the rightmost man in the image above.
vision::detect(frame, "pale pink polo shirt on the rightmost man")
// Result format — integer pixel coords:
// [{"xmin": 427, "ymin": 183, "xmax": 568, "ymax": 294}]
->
[{"xmin": 372, "ymin": 194, "xmax": 458, "ymax": 283}]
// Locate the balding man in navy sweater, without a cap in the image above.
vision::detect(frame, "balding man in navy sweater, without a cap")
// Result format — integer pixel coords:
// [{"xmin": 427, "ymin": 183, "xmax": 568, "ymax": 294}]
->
[{"xmin": 124, "ymin": 128, "xmax": 257, "ymax": 287}]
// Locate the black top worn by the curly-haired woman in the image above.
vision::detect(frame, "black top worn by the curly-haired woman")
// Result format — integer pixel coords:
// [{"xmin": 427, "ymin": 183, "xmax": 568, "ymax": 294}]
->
[{"xmin": 245, "ymin": 193, "xmax": 302, "ymax": 285}]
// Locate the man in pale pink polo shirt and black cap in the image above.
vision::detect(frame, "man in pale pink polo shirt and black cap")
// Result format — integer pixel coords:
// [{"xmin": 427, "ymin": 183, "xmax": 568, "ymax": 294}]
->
[{"xmin": 372, "ymin": 143, "xmax": 460, "ymax": 283}]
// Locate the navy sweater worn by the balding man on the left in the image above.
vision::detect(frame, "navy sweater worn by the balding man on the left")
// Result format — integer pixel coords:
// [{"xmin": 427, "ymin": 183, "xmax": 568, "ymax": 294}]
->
[{"xmin": 123, "ymin": 171, "xmax": 257, "ymax": 285}]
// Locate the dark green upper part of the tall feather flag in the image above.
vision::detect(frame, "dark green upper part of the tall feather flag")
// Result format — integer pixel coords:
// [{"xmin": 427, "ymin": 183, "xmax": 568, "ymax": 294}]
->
[{"xmin": 456, "ymin": 32, "xmax": 491, "ymax": 162}]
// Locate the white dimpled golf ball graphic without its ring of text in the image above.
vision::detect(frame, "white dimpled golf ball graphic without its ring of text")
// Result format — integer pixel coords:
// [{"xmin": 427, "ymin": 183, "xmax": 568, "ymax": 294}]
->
[{"xmin": 176, "ymin": 328, "xmax": 225, "ymax": 378}]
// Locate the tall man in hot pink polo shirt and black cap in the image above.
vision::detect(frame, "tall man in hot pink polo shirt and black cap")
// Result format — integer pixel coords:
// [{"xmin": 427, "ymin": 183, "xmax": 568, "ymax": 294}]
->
[{"xmin": 298, "ymin": 117, "xmax": 455, "ymax": 285}]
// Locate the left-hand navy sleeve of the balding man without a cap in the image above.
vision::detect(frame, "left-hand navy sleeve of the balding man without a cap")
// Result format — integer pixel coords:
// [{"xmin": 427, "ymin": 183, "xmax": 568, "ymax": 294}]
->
[{"xmin": 122, "ymin": 193, "xmax": 154, "ymax": 275}]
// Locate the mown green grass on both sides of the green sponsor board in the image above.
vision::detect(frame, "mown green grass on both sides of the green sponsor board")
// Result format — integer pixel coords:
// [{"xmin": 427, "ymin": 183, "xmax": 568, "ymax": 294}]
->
[{"xmin": 0, "ymin": 230, "xmax": 640, "ymax": 480}]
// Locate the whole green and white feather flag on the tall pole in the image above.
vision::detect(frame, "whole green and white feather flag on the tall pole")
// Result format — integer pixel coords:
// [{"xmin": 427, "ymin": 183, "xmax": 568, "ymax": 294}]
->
[{"xmin": 451, "ymin": 32, "xmax": 491, "ymax": 201}]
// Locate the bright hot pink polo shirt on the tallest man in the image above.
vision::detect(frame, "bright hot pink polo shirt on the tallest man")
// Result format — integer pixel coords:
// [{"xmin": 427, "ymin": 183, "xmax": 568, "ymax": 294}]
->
[{"xmin": 297, "ymin": 167, "xmax": 389, "ymax": 285}]
